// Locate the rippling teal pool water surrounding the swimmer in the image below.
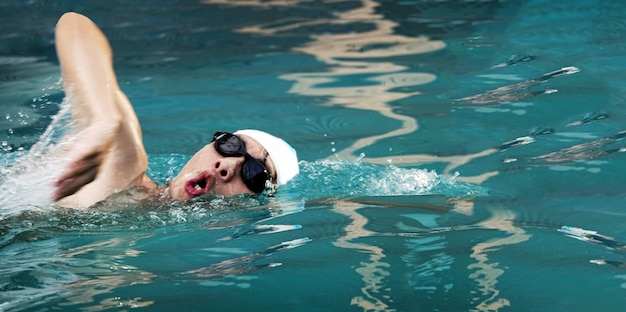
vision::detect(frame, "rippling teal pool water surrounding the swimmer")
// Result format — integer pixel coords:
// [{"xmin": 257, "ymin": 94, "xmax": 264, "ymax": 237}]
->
[{"xmin": 0, "ymin": 0, "xmax": 626, "ymax": 311}]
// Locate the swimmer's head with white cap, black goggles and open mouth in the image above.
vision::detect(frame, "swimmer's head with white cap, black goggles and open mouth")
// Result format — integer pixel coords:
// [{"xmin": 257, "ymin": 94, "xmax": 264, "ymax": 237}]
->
[{"xmin": 168, "ymin": 130, "xmax": 299, "ymax": 200}]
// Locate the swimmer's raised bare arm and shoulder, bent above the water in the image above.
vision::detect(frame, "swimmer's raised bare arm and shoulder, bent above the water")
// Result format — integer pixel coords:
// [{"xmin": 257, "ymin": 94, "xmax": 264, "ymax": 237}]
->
[{"xmin": 55, "ymin": 13, "xmax": 153, "ymax": 208}]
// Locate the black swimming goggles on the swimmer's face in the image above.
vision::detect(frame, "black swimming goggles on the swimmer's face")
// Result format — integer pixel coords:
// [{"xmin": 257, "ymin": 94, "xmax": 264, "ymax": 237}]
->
[{"xmin": 211, "ymin": 132, "xmax": 271, "ymax": 194}]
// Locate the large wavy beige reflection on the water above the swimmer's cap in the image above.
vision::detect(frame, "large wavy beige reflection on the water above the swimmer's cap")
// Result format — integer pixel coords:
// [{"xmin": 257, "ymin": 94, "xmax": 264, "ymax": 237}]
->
[{"xmin": 232, "ymin": 0, "xmax": 445, "ymax": 160}]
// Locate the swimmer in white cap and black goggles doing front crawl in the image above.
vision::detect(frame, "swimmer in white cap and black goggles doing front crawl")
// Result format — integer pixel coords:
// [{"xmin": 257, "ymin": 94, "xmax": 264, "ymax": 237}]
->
[{"xmin": 54, "ymin": 12, "xmax": 299, "ymax": 208}]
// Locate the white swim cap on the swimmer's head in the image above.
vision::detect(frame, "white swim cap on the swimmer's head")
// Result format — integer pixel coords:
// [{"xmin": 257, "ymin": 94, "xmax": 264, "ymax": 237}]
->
[{"xmin": 234, "ymin": 129, "xmax": 300, "ymax": 185}]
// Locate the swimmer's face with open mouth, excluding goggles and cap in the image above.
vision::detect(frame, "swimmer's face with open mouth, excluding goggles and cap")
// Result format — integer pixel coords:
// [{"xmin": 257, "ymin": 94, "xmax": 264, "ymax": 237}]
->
[{"xmin": 168, "ymin": 135, "xmax": 276, "ymax": 200}]
